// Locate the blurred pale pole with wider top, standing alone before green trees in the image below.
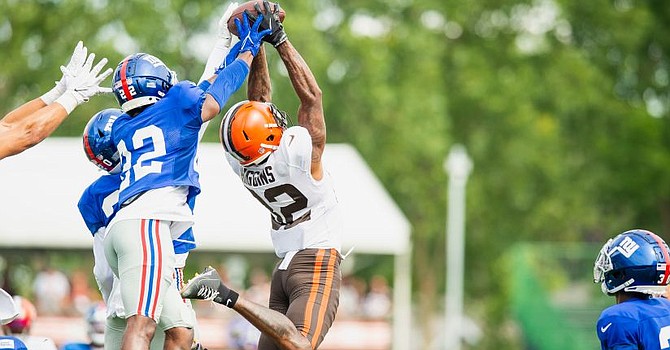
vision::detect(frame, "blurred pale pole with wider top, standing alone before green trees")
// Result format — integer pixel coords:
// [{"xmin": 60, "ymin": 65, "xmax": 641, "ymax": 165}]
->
[{"xmin": 444, "ymin": 144, "xmax": 472, "ymax": 350}]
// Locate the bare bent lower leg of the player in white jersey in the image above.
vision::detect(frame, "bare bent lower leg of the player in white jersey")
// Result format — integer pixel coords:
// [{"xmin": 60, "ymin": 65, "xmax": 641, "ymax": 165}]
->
[{"xmin": 233, "ymin": 298, "xmax": 312, "ymax": 350}]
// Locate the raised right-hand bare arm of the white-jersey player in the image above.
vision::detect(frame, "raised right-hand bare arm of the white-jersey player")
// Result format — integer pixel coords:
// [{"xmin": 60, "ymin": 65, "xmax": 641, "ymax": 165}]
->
[{"xmin": 277, "ymin": 40, "xmax": 326, "ymax": 180}]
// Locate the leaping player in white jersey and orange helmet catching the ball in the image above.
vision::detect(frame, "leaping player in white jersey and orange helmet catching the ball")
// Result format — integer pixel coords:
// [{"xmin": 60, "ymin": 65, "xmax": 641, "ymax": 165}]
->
[{"xmin": 182, "ymin": 2, "xmax": 342, "ymax": 350}]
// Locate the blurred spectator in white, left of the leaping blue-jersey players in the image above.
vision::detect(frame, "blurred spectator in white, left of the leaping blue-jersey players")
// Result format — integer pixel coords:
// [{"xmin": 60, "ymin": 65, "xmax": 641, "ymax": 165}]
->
[{"xmin": 33, "ymin": 266, "xmax": 70, "ymax": 316}]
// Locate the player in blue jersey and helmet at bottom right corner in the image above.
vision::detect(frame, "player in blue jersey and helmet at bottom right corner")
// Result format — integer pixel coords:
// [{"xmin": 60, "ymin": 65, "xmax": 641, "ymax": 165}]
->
[{"xmin": 593, "ymin": 229, "xmax": 670, "ymax": 350}]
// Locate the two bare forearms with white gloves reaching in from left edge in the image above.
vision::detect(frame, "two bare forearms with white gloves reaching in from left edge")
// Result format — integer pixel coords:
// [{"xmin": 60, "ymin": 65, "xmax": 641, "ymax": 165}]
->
[{"xmin": 0, "ymin": 41, "xmax": 112, "ymax": 159}]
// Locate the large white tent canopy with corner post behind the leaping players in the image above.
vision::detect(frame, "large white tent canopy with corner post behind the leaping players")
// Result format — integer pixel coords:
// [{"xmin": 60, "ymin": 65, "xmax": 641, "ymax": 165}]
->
[{"xmin": 0, "ymin": 138, "xmax": 411, "ymax": 349}]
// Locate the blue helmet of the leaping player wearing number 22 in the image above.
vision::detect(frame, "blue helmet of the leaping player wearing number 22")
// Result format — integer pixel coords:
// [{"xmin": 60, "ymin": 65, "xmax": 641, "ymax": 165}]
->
[{"xmin": 112, "ymin": 53, "xmax": 177, "ymax": 113}]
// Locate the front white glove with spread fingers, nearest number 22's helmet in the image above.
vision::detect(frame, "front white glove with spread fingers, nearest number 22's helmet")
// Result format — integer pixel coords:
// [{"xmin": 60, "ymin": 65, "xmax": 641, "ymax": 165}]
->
[{"xmin": 56, "ymin": 53, "xmax": 112, "ymax": 114}]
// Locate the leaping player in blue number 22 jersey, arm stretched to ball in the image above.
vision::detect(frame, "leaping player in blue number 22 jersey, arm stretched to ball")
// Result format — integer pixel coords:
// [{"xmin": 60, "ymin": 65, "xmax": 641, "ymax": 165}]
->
[{"xmin": 104, "ymin": 9, "xmax": 270, "ymax": 349}]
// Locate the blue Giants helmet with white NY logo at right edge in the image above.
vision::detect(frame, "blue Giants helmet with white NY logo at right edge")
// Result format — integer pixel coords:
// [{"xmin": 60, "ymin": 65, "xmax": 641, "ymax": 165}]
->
[{"xmin": 593, "ymin": 229, "xmax": 670, "ymax": 296}]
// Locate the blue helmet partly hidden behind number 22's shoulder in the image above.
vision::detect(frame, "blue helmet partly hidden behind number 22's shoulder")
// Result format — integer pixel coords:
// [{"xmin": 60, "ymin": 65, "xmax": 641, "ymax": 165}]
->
[{"xmin": 84, "ymin": 108, "xmax": 123, "ymax": 174}]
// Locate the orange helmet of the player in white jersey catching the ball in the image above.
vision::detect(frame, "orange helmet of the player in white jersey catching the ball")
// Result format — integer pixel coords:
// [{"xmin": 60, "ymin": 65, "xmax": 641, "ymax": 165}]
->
[{"xmin": 219, "ymin": 101, "xmax": 287, "ymax": 166}]
